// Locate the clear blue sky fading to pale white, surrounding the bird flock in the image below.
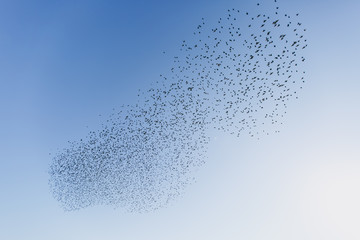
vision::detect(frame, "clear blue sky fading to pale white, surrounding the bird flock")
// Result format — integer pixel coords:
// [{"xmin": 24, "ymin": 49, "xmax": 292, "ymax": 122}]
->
[{"xmin": 0, "ymin": 0, "xmax": 360, "ymax": 240}]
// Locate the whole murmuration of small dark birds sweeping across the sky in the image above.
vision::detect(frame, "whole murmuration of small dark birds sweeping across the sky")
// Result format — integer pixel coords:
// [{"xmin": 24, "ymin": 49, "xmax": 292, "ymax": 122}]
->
[{"xmin": 49, "ymin": 0, "xmax": 307, "ymax": 212}]
